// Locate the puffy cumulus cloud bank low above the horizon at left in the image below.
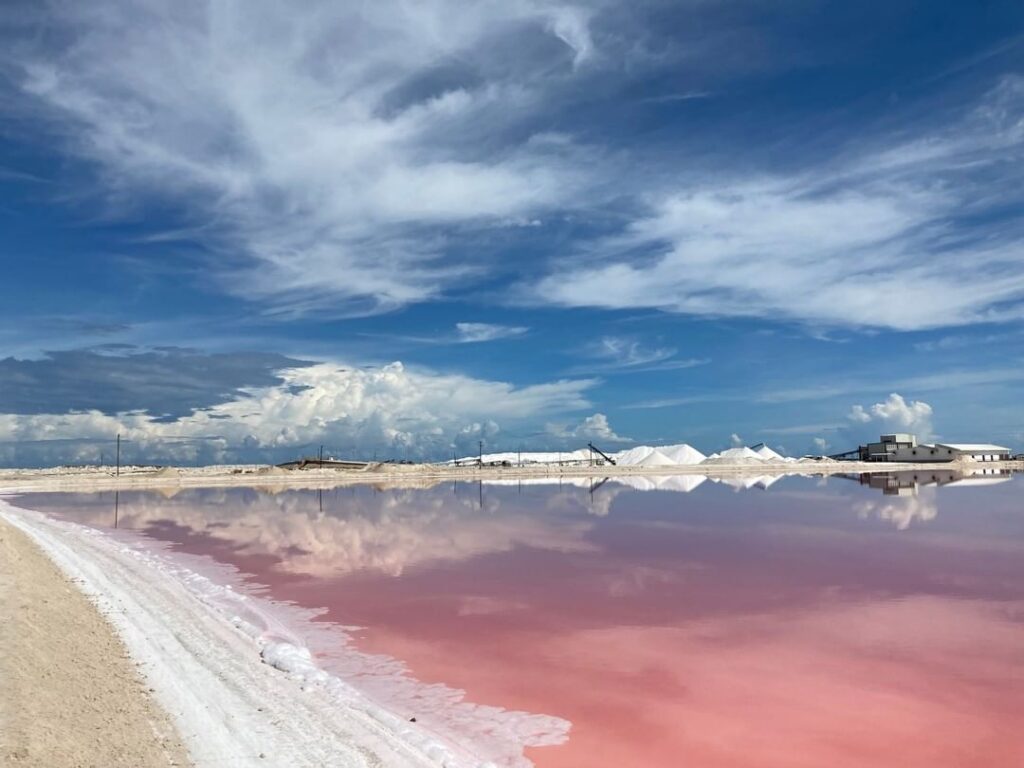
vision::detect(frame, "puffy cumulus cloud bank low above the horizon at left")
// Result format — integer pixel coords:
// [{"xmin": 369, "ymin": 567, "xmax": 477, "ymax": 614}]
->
[{"xmin": 0, "ymin": 362, "xmax": 595, "ymax": 464}]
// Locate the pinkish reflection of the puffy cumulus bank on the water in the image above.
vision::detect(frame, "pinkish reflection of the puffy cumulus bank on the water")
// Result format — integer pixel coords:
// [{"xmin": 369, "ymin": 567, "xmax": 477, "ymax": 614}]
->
[{"xmin": 59, "ymin": 488, "xmax": 591, "ymax": 579}]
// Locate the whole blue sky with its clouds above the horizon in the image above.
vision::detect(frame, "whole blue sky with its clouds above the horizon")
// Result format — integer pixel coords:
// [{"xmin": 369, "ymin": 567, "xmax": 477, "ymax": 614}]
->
[{"xmin": 0, "ymin": 0, "xmax": 1024, "ymax": 464}]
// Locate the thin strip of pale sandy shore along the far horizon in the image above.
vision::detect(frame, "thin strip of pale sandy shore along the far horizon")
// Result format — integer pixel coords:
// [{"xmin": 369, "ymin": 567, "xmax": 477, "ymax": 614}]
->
[{"xmin": 0, "ymin": 461, "xmax": 1024, "ymax": 494}]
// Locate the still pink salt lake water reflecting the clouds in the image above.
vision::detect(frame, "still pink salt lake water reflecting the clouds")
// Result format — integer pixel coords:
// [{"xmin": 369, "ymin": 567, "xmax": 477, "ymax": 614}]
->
[{"xmin": 14, "ymin": 478, "xmax": 1024, "ymax": 768}]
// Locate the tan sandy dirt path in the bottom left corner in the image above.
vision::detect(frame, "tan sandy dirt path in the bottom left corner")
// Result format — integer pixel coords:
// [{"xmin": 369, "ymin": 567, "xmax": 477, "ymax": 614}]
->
[{"xmin": 0, "ymin": 520, "xmax": 189, "ymax": 768}]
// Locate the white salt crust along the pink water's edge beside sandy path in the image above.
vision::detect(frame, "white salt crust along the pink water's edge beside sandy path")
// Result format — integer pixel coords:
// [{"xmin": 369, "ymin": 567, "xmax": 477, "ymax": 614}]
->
[{"xmin": 0, "ymin": 500, "xmax": 568, "ymax": 768}]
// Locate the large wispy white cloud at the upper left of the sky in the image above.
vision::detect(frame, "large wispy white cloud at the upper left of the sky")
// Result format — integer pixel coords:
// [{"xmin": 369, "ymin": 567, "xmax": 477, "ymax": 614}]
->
[{"xmin": 6, "ymin": 0, "xmax": 594, "ymax": 313}]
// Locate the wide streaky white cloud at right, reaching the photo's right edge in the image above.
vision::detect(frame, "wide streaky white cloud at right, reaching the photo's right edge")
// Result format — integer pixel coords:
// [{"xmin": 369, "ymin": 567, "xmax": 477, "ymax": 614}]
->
[{"xmin": 530, "ymin": 78, "xmax": 1024, "ymax": 330}]
